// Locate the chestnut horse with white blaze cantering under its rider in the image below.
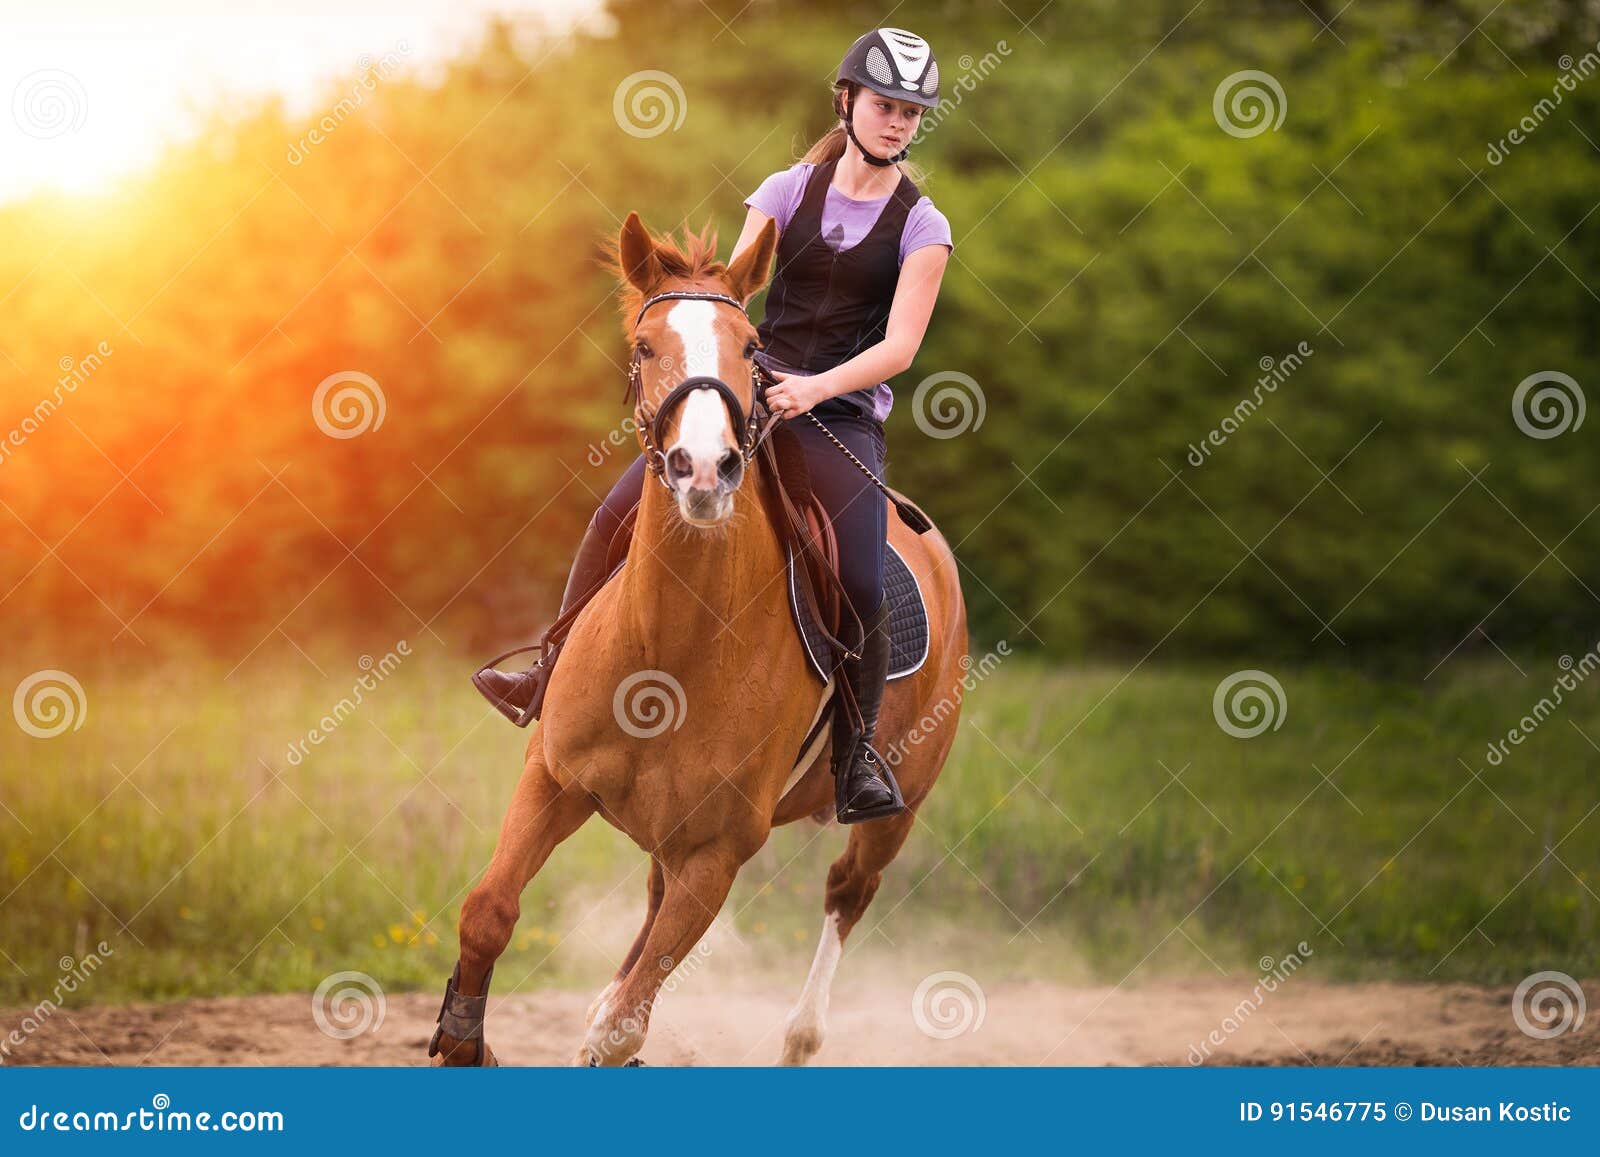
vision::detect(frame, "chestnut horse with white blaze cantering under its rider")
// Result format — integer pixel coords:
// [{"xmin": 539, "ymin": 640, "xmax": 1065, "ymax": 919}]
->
[{"xmin": 435, "ymin": 214, "xmax": 966, "ymax": 1064}]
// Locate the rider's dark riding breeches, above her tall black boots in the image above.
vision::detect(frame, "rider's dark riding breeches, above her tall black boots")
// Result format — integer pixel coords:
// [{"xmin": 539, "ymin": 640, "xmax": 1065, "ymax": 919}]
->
[{"xmin": 594, "ymin": 398, "xmax": 888, "ymax": 619}]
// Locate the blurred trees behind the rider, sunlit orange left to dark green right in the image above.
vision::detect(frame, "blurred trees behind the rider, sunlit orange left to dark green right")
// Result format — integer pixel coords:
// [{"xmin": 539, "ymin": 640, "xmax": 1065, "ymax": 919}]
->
[{"xmin": 0, "ymin": 0, "xmax": 1600, "ymax": 664}]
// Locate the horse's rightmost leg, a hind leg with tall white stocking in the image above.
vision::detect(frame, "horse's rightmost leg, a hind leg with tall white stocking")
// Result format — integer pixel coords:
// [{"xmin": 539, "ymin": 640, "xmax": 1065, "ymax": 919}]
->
[{"xmin": 782, "ymin": 811, "xmax": 915, "ymax": 1064}]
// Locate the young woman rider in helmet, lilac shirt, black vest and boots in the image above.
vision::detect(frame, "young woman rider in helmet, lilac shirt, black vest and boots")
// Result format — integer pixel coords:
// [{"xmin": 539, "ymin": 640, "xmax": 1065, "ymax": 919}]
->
[{"xmin": 474, "ymin": 27, "xmax": 954, "ymax": 823}]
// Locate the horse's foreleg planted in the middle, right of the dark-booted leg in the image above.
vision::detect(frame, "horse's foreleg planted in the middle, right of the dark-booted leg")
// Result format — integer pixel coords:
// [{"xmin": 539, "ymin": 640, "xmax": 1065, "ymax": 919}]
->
[{"xmin": 573, "ymin": 850, "xmax": 739, "ymax": 1064}]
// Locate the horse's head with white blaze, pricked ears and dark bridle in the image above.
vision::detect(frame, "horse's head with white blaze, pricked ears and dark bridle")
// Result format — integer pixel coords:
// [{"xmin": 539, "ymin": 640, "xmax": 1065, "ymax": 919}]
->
[{"xmin": 616, "ymin": 213, "xmax": 778, "ymax": 526}]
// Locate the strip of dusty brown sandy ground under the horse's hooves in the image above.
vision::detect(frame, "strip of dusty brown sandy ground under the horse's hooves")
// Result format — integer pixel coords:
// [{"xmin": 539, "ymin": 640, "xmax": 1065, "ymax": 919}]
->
[{"xmin": 0, "ymin": 979, "xmax": 1600, "ymax": 1066}]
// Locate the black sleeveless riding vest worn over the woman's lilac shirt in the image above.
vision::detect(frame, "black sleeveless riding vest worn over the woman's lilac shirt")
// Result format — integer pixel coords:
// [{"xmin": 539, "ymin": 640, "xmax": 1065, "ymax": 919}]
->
[{"xmin": 757, "ymin": 160, "xmax": 922, "ymax": 392}]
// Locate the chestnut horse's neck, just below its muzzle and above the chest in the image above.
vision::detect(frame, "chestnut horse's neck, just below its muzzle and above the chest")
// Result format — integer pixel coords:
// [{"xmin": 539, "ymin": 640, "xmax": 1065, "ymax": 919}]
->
[{"xmin": 621, "ymin": 470, "xmax": 789, "ymax": 658}]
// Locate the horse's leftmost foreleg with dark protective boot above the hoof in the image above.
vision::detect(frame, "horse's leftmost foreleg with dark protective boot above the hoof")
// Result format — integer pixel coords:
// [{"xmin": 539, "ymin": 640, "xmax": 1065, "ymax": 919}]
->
[{"xmin": 430, "ymin": 744, "xmax": 594, "ymax": 1066}]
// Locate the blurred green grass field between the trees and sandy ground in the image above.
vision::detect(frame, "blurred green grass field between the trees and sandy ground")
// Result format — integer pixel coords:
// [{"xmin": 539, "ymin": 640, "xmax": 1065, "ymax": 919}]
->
[{"xmin": 0, "ymin": 653, "xmax": 1600, "ymax": 1003}]
